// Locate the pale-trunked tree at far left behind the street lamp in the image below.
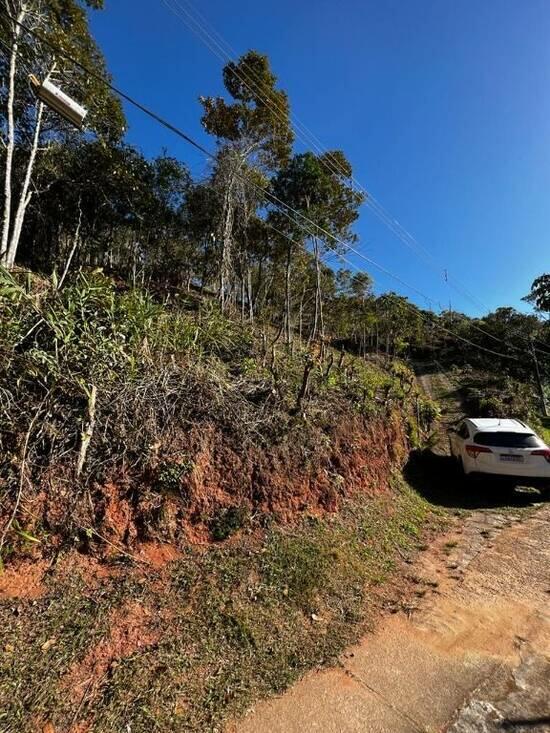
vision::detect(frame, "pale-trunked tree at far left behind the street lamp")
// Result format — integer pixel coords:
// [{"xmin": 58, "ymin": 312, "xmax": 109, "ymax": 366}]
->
[{"xmin": 0, "ymin": 0, "xmax": 124, "ymax": 267}]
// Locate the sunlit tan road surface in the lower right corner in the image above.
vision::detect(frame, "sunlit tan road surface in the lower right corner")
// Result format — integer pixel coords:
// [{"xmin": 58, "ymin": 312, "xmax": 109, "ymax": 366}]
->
[{"xmin": 233, "ymin": 504, "xmax": 550, "ymax": 733}]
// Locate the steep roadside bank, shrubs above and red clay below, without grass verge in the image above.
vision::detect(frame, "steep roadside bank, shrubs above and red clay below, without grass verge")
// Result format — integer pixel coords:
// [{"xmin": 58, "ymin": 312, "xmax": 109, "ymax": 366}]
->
[{"xmin": 0, "ymin": 272, "xmax": 437, "ymax": 562}]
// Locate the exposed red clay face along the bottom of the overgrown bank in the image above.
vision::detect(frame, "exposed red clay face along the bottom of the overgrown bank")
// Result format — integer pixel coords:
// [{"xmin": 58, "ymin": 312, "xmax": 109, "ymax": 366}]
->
[{"xmin": 4, "ymin": 412, "xmax": 407, "ymax": 556}]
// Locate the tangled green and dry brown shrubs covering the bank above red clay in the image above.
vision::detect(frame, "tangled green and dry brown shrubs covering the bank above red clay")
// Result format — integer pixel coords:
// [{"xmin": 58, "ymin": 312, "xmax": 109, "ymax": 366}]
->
[{"xmin": 0, "ymin": 270, "xmax": 420, "ymax": 552}]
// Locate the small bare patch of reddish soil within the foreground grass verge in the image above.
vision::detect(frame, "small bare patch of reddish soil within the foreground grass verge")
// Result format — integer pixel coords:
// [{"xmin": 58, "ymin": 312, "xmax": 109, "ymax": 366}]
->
[{"xmin": 65, "ymin": 602, "xmax": 159, "ymax": 703}]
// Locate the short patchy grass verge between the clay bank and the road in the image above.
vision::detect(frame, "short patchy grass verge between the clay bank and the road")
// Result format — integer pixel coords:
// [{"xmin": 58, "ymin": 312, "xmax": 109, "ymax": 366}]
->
[{"xmin": 0, "ymin": 479, "xmax": 443, "ymax": 733}]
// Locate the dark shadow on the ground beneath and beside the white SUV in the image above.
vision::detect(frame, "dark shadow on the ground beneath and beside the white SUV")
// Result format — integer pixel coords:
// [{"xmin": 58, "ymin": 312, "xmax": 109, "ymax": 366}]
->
[{"xmin": 404, "ymin": 451, "xmax": 541, "ymax": 509}]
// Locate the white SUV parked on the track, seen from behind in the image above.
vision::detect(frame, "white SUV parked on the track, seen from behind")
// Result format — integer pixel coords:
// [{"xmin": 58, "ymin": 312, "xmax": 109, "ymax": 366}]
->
[{"xmin": 449, "ymin": 418, "xmax": 550, "ymax": 486}]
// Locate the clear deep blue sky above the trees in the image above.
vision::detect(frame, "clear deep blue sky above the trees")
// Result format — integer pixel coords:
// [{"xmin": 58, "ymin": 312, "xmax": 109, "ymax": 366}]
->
[{"xmin": 92, "ymin": 0, "xmax": 550, "ymax": 315}]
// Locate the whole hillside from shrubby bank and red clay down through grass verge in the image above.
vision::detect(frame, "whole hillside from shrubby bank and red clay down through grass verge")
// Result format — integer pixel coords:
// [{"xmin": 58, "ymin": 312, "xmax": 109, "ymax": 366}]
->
[{"xmin": 0, "ymin": 272, "xmax": 440, "ymax": 733}]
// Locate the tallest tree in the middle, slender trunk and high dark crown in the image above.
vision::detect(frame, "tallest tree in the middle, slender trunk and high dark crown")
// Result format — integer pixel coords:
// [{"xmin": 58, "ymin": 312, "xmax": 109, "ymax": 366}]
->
[{"xmin": 200, "ymin": 51, "xmax": 293, "ymax": 308}]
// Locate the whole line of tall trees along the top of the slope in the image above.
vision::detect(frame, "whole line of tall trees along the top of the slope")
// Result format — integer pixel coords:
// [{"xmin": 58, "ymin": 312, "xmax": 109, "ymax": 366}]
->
[{"xmin": 0, "ymin": 0, "xmax": 550, "ymax": 400}]
